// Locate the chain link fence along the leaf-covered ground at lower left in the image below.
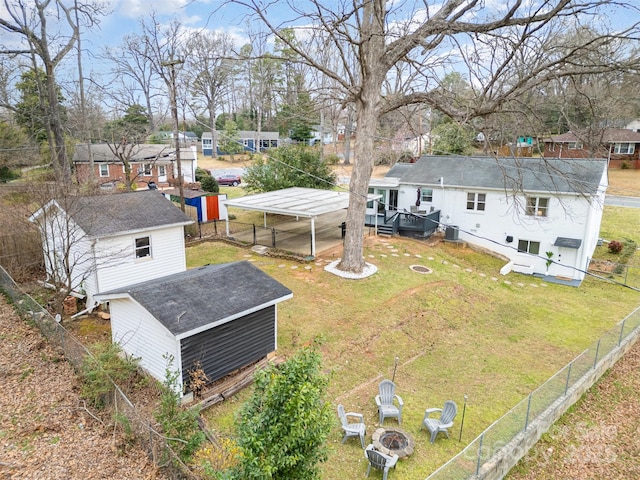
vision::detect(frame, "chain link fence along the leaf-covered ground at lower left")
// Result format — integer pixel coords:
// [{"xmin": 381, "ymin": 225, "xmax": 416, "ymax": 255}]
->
[{"xmin": 0, "ymin": 267, "xmax": 199, "ymax": 479}]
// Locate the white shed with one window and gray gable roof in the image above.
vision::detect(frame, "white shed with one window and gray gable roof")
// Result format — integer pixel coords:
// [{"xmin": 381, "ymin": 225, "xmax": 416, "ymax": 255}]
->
[{"xmin": 30, "ymin": 190, "xmax": 193, "ymax": 308}]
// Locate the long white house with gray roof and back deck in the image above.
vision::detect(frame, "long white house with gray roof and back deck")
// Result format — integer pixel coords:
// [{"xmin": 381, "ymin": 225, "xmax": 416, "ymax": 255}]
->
[{"xmin": 367, "ymin": 156, "xmax": 607, "ymax": 282}]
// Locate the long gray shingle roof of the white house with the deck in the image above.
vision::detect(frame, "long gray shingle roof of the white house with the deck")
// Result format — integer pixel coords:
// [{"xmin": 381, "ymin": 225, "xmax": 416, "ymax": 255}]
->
[{"xmin": 387, "ymin": 155, "xmax": 607, "ymax": 194}]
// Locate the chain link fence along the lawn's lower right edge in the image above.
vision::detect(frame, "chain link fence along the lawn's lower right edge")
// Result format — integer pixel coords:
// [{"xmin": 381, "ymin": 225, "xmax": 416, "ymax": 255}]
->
[{"xmin": 427, "ymin": 308, "xmax": 640, "ymax": 480}]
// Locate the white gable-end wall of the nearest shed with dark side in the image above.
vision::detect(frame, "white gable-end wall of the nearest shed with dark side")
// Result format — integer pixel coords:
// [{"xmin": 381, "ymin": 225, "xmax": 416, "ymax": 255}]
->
[{"xmin": 109, "ymin": 298, "xmax": 182, "ymax": 391}]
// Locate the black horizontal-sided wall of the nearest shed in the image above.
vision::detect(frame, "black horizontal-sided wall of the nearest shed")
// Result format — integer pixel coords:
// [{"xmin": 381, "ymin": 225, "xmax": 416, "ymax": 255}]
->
[{"xmin": 180, "ymin": 305, "xmax": 276, "ymax": 388}]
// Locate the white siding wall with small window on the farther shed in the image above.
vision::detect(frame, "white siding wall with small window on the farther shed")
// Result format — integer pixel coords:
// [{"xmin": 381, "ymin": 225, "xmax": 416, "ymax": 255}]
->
[{"xmin": 96, "ymin": 226, "xmax": 187, "ymax": 300}]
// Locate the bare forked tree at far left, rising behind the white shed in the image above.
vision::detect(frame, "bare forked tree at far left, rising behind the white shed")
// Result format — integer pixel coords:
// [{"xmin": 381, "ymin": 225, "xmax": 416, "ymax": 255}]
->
[{"xmin": 0, "ymin": 0, "xmax": 103, "ymax": 183}]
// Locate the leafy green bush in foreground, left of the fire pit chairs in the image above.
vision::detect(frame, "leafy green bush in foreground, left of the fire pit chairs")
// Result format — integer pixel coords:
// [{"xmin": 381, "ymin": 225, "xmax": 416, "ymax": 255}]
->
[{"xmin": 233, "ymin": 347, "xmax": 333, "ymax": 480}]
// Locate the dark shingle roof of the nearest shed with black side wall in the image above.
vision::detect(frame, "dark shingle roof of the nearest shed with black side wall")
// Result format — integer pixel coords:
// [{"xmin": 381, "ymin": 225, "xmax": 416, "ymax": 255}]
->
[{"xmin": 101, "ymin": 261, "xmax": 292, "ymax": 336}]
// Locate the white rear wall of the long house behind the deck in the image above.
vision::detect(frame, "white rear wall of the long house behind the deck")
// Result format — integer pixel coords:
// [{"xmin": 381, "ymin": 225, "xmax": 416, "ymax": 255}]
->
[{"xmin": 398, "ymin": 185, "xmax": 603, "ymax": 279}]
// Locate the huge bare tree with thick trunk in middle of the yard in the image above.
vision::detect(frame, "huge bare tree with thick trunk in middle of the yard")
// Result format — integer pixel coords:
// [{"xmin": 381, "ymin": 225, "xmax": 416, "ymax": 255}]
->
[{"xmin": 235, "ymin": 0, "xmax": 638, "ymax": 273}]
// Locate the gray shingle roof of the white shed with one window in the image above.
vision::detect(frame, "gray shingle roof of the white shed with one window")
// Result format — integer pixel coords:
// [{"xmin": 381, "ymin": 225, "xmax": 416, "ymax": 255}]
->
[{"xmin": 63, "ymin": 190, "xmax": 193, "ymax": 238}]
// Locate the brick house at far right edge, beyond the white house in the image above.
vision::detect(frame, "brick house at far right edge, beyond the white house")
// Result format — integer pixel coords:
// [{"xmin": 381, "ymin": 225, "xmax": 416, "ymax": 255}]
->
[{"xmin": 543, "ymin": 128, "xmax": 640, "ymax": 169}]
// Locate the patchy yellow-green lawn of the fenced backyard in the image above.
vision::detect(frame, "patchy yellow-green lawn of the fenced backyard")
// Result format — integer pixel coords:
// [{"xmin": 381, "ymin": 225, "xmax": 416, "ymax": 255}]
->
[{"xmin": 187, "ymin": 215, "xmax": 640, "ymax": 480}]
